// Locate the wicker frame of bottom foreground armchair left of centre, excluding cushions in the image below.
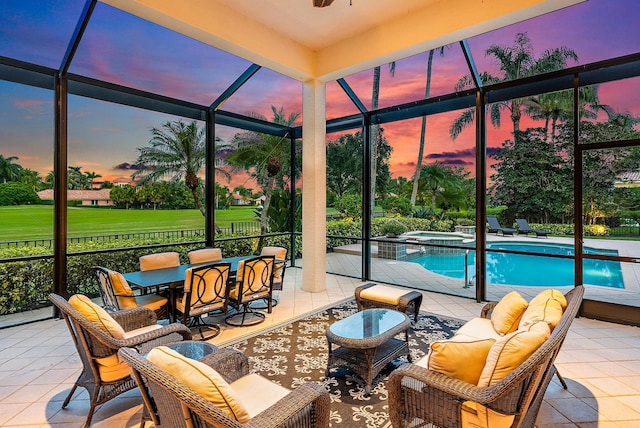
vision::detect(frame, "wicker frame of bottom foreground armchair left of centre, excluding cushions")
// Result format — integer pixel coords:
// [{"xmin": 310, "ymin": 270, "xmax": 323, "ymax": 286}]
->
[{"xmin": 118, "ymin": 348, "xmax": 330, "ymax": 428}]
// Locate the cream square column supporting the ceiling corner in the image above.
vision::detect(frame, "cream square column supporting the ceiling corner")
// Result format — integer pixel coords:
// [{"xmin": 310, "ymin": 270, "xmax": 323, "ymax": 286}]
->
[{"xmin": 302, "ymin": 80, "xmax": 327, "ymax": 293}]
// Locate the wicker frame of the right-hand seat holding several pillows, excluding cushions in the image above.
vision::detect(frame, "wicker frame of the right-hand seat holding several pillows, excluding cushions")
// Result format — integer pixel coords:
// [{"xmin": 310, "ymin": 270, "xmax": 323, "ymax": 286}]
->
[{"xmin": 388, "ymin": 285, "xmax": 584, "ymax": 428}]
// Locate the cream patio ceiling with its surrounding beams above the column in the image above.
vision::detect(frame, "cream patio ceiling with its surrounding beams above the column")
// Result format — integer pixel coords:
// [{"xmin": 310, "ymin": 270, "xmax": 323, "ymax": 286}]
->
[{"xmin": 102, "ymin": 0, "xmax": 585, "ymax": 81}]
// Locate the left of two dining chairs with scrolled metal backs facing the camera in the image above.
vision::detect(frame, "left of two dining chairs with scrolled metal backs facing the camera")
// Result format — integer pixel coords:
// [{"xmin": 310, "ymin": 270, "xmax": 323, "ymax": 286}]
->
[{"xmin": 176, "ymin": 263, "xmax": 231, "ymax": 339}]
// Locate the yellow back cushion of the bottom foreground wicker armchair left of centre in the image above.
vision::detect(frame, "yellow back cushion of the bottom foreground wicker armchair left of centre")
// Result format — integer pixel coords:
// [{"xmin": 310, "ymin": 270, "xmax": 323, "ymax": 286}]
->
[{"xmin": 147, "ymin": 346, "xmax": 250, "ymax": 423}]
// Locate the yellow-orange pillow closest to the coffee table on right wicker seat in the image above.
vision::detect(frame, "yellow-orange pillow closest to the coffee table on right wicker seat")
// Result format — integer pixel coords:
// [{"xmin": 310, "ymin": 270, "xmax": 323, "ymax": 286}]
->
[{"xmin": 427, "ymin": 338, "xmax": 495, "ymax": 385}]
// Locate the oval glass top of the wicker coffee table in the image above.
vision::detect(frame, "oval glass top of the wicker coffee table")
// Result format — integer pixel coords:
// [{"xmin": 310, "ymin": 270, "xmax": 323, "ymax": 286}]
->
[{"xmin": 329, "ymin": 309, "xmax": 406, "ymax": 339}]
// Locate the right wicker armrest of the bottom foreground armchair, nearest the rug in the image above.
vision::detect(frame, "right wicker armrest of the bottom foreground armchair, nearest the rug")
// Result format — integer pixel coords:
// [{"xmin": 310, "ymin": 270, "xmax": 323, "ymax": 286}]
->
[{"xmin": 243, "ymin": 382, "xmax": 331, "ymax": 428}]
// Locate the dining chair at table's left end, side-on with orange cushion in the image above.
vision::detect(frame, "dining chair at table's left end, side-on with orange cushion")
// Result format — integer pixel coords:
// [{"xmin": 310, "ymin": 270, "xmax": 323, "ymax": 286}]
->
[{"xmin": 93, "ymin": 266, "xmax": 169, "ymax": 319}]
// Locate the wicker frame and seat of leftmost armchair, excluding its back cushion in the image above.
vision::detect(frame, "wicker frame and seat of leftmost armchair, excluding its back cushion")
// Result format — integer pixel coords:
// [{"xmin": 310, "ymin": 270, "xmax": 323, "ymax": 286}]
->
[{"xmin": 49, "ymin": 293, "xmax": 191, "ymax": 427}]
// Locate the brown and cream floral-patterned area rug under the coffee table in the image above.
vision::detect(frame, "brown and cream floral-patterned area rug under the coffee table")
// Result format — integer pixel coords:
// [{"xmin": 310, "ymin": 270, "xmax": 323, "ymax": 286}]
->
[{"xmin": 230, "ymin": 300, "xmax": 464, "ymax": 428}]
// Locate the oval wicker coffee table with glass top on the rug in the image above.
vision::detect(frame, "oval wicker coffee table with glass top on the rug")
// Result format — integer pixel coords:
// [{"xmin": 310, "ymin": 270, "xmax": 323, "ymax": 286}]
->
[{"xmin": 325, "ymin": 309, "xmax": 411, "ymax": 394}]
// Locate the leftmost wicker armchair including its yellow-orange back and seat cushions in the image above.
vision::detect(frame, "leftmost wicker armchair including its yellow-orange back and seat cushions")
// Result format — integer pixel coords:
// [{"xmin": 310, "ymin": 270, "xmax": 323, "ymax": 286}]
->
[{"xmin": 49, "ymin": 293, "xmax": 191, "ymax": 427}]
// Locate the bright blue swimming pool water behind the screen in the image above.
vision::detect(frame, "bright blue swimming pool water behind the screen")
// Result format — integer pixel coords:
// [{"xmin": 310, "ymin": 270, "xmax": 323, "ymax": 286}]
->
[{"xmin": 411, "ymin": 242, "xmax": 624, "ymax": 288}]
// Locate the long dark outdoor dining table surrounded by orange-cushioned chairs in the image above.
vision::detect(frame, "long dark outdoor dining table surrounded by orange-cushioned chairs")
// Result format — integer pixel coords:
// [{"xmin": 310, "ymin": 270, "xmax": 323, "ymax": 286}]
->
[{"xmin": 123, "ymin": 256, "xmax": 254, "ymax": 322}]
